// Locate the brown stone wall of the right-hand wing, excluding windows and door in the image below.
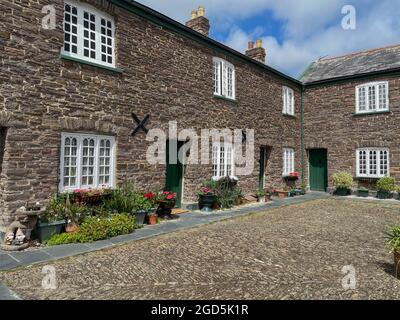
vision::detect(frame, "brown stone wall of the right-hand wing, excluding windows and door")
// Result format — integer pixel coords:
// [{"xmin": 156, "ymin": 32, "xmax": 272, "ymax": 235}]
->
[{"xmin": 304, "ymin": 76, "xmax": 400, "ymax": 187}]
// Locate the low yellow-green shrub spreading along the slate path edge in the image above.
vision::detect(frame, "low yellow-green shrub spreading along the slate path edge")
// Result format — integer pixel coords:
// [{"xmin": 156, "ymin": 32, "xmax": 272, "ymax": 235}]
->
[{"xmin": 45, "ymin": 214, "xmax": 136, "ymax": 246}]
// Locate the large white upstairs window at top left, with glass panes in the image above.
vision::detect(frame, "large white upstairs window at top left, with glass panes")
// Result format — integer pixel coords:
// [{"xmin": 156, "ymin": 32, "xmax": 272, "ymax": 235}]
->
[{"xmin": 61, "ymin": 0, "xmax": 115, "ymax": 67}]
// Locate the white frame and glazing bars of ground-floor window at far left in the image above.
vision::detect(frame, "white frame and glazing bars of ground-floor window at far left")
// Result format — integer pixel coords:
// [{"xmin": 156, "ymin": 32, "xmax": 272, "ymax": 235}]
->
[{"xmin": 59, "ymin": 132, "xmax": 116, "ymax": 191}]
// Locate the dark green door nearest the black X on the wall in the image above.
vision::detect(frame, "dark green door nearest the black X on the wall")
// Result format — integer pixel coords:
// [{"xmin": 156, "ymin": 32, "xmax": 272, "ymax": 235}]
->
[{"xmin": 165, "ymin": 140, "xmax": 183, "ymax": 208}]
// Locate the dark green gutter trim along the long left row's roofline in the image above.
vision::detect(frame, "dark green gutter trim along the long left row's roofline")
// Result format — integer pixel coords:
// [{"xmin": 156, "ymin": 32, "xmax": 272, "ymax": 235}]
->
[{"xmin": 108, "ymin": 0, "xmax": 302, "ymax": 88}]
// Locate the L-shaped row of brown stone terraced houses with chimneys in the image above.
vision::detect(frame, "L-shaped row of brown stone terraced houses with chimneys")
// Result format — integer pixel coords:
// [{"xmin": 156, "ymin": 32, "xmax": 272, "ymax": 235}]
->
[{"xmin": 0, "ymin": 0, "xmax": 400, "ymax": 230}]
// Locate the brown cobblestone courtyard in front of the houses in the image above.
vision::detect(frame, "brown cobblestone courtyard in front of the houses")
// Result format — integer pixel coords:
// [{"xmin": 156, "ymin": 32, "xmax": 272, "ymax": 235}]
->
[{"xmin": 0, "ymin": 198, "xmax": 400, "ymax": 299}]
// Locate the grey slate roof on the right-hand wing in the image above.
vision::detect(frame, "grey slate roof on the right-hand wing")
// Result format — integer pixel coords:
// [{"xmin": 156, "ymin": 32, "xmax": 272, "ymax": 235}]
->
[{"xmin": 300, "ymin": 45, "xmax": 400, "ymax": 84}]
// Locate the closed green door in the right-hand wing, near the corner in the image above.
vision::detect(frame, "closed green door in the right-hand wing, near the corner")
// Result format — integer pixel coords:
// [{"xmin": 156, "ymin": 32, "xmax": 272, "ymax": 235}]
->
[{"xmin": 309, "ymin": 149, "xmax": 328, "ymax": 191}]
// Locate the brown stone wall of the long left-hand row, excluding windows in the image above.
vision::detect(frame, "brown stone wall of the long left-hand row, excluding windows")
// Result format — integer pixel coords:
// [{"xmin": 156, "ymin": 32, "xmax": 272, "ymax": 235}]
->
[{"xmin": 0, "ymin": 0, "xmax": 300, "ymax": 225}]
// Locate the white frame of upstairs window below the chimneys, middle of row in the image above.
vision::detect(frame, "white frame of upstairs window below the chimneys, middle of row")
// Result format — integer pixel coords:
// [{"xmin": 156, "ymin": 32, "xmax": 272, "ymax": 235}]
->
[{"xmin": 213, "ymin": 57, "xmax": 236, "ymax": 100}]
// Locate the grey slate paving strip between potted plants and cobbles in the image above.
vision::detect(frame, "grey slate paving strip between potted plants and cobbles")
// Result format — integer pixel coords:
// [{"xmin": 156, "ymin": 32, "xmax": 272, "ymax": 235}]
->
[{"xmin": 0, "ymin": 192, "xmax": 330, "ymax": 271}]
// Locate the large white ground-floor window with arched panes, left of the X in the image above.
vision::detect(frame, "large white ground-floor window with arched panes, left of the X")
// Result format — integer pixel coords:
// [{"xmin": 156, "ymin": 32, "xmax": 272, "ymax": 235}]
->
[{"xmin": 60, "ymin": 133, "xmax": 115, "ymax": 190}]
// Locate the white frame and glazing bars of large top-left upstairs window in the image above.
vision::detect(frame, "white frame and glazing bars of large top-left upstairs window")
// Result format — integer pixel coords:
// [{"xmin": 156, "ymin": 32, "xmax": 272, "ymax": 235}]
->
[{"xmin": 61, "ymin": 0, "xmax": 116, "ymax": 68}]
